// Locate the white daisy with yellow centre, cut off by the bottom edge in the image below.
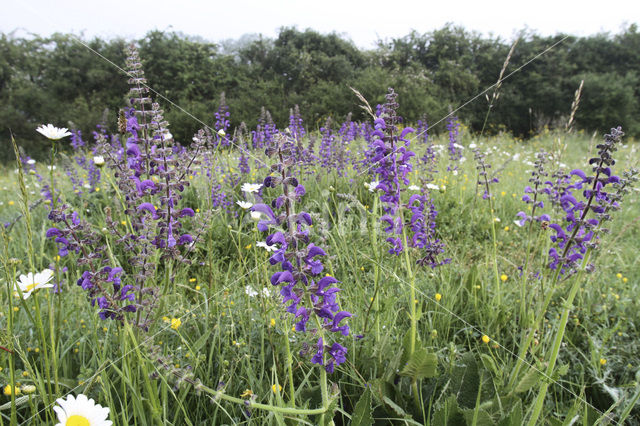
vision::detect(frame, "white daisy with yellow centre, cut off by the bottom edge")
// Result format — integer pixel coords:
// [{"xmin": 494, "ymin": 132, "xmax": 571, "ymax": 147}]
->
[{"xmin": 53, "ymin": 394, "xmax": 113, "ymax": 426}]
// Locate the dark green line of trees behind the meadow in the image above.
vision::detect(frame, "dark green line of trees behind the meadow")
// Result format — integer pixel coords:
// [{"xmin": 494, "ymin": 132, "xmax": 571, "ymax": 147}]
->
[{"xmin": 0, "ymin": 24, "xmax": 640, "ymax": 161}]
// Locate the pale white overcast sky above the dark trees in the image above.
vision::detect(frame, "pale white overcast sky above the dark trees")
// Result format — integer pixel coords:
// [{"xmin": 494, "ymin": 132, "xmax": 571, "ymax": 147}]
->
[{"xmin": 0, "ymin": 0, "xmax": 640, "ymax": 48}]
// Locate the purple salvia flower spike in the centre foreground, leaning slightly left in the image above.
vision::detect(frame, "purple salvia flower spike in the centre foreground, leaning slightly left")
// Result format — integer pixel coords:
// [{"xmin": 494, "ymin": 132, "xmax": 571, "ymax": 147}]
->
[{"xmin": 252, "ymin": 136, "xmax": 351, "ymax": 373}]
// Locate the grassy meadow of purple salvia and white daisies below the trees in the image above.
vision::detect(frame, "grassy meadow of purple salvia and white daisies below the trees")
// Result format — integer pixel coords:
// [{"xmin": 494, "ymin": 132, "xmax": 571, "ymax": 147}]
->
[{"xmin": 0, "ymin": 44, "xmax": 640, "ymax": 426}]
